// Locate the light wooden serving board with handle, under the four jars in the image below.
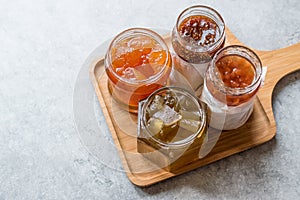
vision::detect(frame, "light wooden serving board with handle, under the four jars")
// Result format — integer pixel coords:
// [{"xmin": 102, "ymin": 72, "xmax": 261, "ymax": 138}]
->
[{"xmin": 90, "ymin": 29, "xmax": 300, "ymax": 186}]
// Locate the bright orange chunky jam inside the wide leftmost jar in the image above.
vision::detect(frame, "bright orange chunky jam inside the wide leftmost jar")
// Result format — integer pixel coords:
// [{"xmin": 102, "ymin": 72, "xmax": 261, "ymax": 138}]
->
[{"xmin": 106, "ymin": 46, "xmax": 171, "ymax": 113}]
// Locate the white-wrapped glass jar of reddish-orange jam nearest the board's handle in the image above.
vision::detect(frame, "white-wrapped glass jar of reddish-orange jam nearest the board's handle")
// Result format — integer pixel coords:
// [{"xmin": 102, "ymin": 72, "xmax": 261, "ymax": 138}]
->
[{"xmin": 202, "ymin": 45, "xmax": 262, "ymax": 130}]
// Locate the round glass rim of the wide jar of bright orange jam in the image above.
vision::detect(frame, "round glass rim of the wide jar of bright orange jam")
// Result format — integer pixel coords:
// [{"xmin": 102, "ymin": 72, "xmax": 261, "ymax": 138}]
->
[{"xmin": 104, "ymin": 28, "xmax": 171, "ymax": 84}]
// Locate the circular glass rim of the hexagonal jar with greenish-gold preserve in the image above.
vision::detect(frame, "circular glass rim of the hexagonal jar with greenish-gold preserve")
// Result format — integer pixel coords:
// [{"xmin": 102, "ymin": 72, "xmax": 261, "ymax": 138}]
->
[{"xmin": 140, "ymin": 86, "xmax": 206, "ymax": 148}]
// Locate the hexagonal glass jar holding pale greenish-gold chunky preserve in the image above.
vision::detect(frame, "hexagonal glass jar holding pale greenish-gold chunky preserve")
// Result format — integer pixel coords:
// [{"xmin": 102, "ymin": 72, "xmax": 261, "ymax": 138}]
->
[{"xmin": 137, "ymin": 87, "xmax": 207, "ymax": 171}]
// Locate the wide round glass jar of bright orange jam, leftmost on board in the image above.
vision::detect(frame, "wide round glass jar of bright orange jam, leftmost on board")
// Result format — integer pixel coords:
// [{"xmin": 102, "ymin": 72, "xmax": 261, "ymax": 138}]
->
[{"xmin": 105, "ymin": 28, "xmax": 172, "ymax": 113}]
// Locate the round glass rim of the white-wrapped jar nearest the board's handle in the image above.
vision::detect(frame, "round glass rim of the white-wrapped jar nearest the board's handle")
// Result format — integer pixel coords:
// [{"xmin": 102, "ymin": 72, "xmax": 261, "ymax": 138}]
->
[{"xmin": 209, "ymin": 45, "xmax": 262, "ymax": 95}]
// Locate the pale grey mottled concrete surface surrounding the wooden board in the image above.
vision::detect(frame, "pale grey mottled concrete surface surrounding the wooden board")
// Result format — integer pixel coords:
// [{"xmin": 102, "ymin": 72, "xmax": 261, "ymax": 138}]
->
[{"xmin": 0, "ymin": 0, "xmax": 300, "ymax": 200}]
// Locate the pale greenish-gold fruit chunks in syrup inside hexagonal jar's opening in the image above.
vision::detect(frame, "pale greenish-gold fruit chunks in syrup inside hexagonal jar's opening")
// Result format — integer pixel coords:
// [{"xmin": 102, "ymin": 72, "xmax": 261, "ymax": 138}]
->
[{"xmin": 146, "ymin": 92, "xmax": 202, "ymax": 143}]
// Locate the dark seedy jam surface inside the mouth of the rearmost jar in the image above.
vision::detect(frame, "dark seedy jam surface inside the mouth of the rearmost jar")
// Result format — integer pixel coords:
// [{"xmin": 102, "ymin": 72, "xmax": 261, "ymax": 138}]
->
[{"xmin": 179, "ymin": 15, "xmax": 220, "ymax": 46}]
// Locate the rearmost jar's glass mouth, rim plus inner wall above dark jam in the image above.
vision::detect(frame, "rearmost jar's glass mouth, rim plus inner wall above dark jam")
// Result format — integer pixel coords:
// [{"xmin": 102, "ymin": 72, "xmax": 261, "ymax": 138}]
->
[{"xmin": 175, "ymin": 5, "xmax": 225, "ymax": 52}]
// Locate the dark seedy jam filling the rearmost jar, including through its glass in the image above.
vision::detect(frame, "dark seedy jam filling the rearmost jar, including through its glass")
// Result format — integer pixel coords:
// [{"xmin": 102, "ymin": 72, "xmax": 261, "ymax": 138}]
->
[{"xmin": 172, "ymin": 15, "xmax": 225, "ymax": 64}]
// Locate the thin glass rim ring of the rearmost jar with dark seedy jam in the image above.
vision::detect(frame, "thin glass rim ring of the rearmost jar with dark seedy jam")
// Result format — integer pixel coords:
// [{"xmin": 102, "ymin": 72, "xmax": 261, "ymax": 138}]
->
[{"xmin": 175, "ymin": 5, "xmax": 225, "ymax": 52}]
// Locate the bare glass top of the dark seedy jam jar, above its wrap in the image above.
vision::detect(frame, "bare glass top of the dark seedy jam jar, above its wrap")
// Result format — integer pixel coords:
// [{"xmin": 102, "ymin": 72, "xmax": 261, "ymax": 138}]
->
[{"xmin": 172, "ymin": 5, "xmax": 225, "ymax": 64}]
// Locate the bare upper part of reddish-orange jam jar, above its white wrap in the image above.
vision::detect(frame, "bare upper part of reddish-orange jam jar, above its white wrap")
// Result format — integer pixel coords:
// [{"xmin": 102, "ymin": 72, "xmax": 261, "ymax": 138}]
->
[{"xmin": 205, "ymin": 45, "xmax": 262, "ymax": 106}]
